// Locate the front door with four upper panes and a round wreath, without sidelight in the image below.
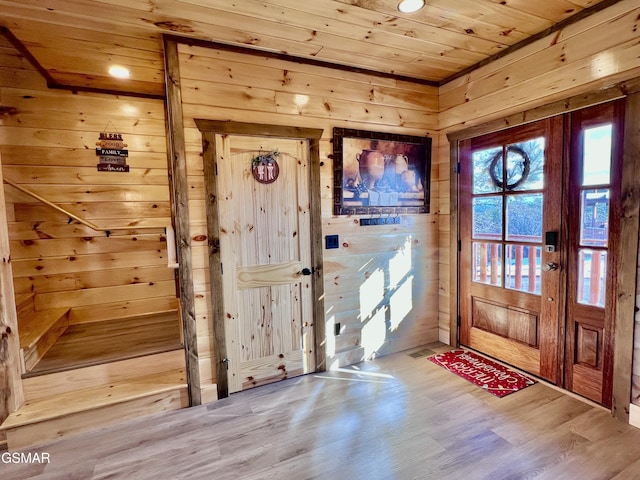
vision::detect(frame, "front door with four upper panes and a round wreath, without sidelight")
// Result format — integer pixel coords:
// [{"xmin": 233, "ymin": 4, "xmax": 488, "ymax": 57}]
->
[{"xmin": 459, "ymin": 118, "xmax": 563, "ymax": 383}]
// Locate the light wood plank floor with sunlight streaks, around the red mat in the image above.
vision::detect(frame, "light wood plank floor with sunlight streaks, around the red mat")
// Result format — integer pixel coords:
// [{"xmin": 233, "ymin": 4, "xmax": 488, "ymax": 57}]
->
[{"xmin": 0, "ymin": 345, "xmax": 640, "ymax": 480}]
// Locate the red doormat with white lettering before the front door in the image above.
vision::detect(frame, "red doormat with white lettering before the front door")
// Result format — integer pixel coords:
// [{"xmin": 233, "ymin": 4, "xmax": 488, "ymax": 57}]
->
[{"xmin": 429, "ymin": 349, "xmax": 537, "ymax": 397}]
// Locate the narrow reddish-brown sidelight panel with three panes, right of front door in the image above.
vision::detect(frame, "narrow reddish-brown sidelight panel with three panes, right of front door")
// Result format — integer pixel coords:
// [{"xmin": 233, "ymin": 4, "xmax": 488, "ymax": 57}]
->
[{"xmin": 565, "ymin": 101, "xmax": 624, "ymax": 407}]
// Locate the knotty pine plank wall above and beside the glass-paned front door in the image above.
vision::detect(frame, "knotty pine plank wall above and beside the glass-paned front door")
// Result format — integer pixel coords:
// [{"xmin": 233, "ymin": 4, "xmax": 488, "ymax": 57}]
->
[{"xmin": 436, "ymin": 0, "xmax": 640, "ymax": 405}]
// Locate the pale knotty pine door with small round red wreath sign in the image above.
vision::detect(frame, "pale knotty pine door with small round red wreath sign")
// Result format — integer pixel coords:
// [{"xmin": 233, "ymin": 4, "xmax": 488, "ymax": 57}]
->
[{"xmin": 215, "ymin": 135, "xmax": 315, "ymax": 393}]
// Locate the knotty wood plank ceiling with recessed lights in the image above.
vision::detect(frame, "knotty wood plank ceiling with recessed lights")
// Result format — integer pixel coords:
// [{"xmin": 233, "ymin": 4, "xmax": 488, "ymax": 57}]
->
[{"xmin": 0, "ymin": 0, "xmax": 615, "ymax": 96}]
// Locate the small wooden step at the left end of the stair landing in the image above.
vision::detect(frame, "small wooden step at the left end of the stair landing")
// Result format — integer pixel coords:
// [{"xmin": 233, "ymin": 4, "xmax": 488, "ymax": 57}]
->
[{"xmin": 18, "ymin": 308, "xmax": 69, "ymax": 372}]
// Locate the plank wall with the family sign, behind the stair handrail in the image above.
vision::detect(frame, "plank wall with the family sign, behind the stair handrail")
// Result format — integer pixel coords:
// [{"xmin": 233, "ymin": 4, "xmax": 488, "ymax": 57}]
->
[{"xmin": 0, "ymin": 37, "xmax": 177, "ymax": 340}]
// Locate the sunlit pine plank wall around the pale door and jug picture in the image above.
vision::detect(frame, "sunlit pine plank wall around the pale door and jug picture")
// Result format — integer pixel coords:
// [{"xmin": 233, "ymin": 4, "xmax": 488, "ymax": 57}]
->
[{"xmin": 178, "ymin": 41, "xmax": 438, "ymax": 401}]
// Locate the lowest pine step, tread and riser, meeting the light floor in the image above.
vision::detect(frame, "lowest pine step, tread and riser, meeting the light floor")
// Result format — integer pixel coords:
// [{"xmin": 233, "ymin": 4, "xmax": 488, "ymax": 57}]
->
[{"xmin": 0, "ymin": 368, "xmax": 188, "ymax": 450}]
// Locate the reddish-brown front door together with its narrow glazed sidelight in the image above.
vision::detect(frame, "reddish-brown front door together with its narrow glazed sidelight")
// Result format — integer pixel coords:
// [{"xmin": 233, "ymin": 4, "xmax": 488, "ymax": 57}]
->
[{"xmin": 459, "ymin": 101, "xmax": 623, "ymax": 407}]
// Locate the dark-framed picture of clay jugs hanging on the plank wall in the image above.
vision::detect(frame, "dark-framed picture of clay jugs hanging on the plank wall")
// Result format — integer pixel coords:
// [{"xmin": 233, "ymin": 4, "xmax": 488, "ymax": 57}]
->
[{"xmin": 333, "ymin": 127, "xmax": 431, "ymax": 215}]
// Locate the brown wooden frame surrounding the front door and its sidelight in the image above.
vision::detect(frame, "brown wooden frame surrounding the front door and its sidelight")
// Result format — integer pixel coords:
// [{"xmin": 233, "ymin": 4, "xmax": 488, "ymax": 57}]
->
[{"xmin": 447, "ymin": 78, "xmax": 640, "ymax": 423}]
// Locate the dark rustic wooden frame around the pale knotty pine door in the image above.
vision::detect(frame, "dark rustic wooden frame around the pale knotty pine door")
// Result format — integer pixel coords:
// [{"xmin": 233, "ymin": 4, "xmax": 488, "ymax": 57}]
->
[{"xmin": 195, "ymin": 119, "xmax": 326, "ymax": 398}]
